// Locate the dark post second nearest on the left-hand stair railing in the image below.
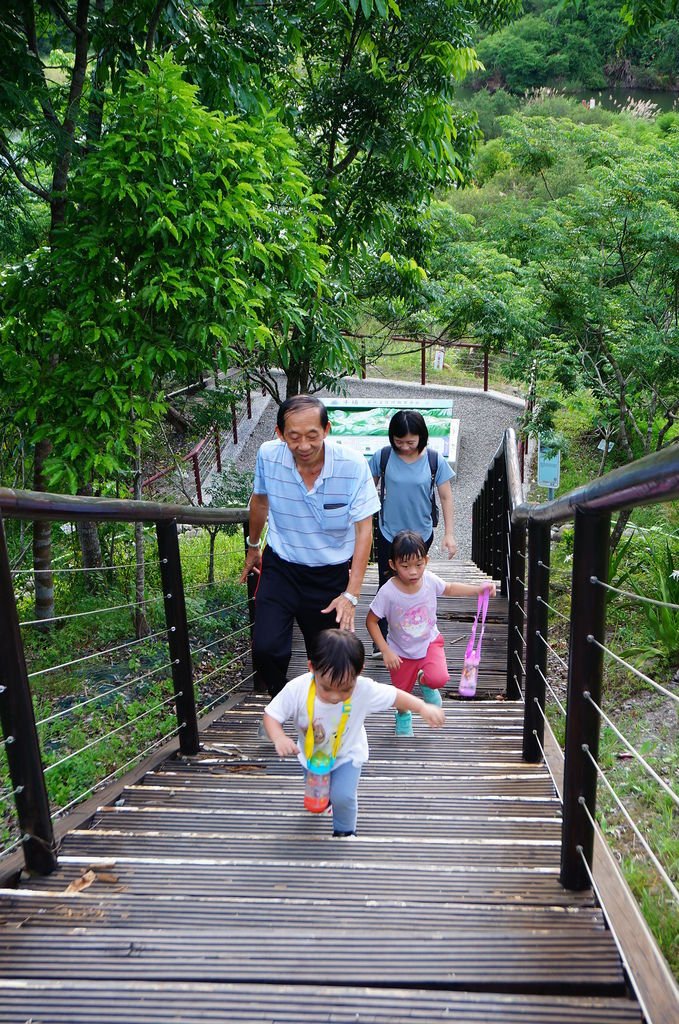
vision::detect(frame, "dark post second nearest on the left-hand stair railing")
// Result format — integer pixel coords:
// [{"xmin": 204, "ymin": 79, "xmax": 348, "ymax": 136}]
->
[{"xmin": 156, "ymin": 519, "xmax": 200, "ymax": 755}]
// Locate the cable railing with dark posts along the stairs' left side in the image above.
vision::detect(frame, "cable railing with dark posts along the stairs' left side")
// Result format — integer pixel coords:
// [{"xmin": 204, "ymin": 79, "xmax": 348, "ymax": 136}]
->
[{"xmin": 0, "ymin": 488, "xmax": 253, "ymax": 871}]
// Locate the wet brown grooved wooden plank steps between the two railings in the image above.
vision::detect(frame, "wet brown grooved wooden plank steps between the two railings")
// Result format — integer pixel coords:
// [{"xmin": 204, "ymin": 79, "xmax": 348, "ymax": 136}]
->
[{"xmin": 0, "ymin": 565, "xmax": 641, "ymax": 1024}]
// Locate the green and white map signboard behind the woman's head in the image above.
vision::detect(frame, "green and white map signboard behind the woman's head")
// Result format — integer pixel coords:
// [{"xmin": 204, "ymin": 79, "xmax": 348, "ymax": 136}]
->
[{"xmin": 326, "ymin": 398, "xmax": 459, "ymax": 462}]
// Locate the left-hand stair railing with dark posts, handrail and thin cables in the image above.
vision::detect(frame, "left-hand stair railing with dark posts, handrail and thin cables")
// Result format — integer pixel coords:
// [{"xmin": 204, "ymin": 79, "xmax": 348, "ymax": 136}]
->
[{"xmin": 0, "ymin": 488, "xmax": 253, "ymax": 873}]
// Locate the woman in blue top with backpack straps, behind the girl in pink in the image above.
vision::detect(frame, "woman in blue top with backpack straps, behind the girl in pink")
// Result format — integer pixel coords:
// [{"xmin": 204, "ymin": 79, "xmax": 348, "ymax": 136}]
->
[{"xmin": 370, "ymin": 409, "xmax": 458, "ymax": 653}]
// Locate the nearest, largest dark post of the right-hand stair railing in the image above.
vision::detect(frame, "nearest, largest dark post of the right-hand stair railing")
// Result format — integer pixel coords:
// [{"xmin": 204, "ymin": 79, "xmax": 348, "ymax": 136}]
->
[{"xmin": 560, "ymin": 512, "xmax": 610, "ymax": 890}]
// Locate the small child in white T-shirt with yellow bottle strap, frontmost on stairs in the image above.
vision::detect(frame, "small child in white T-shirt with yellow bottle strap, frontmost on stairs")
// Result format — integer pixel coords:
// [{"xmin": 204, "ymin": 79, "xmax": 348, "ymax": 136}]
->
[{"xmin": 264, "ymin": 630, "xmax": 445, "ymax": 838}]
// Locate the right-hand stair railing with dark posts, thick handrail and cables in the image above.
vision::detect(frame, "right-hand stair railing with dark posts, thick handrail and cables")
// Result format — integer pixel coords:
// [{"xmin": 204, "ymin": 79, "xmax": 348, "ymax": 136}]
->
[{"xmin": 472, "ymin": 430, "xmax": 679, "ymax": 1021}]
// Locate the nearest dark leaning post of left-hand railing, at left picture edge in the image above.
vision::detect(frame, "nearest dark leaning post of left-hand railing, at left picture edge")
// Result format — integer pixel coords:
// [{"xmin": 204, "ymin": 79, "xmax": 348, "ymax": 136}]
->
[{"xmin": 0, "ymin": 518, "xmax": 57, "ymax": 874}]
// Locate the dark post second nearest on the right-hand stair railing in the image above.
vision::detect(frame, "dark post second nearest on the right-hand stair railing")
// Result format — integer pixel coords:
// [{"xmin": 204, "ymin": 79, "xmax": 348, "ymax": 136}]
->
[{"xmin": 523, "ymin": 521, "xmax": 551, "ymax": 764}]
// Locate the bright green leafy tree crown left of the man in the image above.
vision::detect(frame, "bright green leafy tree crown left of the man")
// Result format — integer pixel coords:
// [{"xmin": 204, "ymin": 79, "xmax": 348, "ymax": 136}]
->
[{"xmin": 0, "ymin": 57, "xmax": 325, "ymax": 488}]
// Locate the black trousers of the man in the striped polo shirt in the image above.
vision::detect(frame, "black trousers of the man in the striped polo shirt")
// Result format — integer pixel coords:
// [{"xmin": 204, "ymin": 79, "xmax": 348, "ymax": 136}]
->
[{"xmin": 252, "ymin": 547, "xmax": 351, "ymax": 696}]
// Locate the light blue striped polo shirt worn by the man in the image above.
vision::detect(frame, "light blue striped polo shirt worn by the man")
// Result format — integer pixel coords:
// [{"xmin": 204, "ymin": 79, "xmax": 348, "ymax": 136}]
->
[{"xmin": 252, "ymin": 438, "xmax": 380, "ymax": 565}]
